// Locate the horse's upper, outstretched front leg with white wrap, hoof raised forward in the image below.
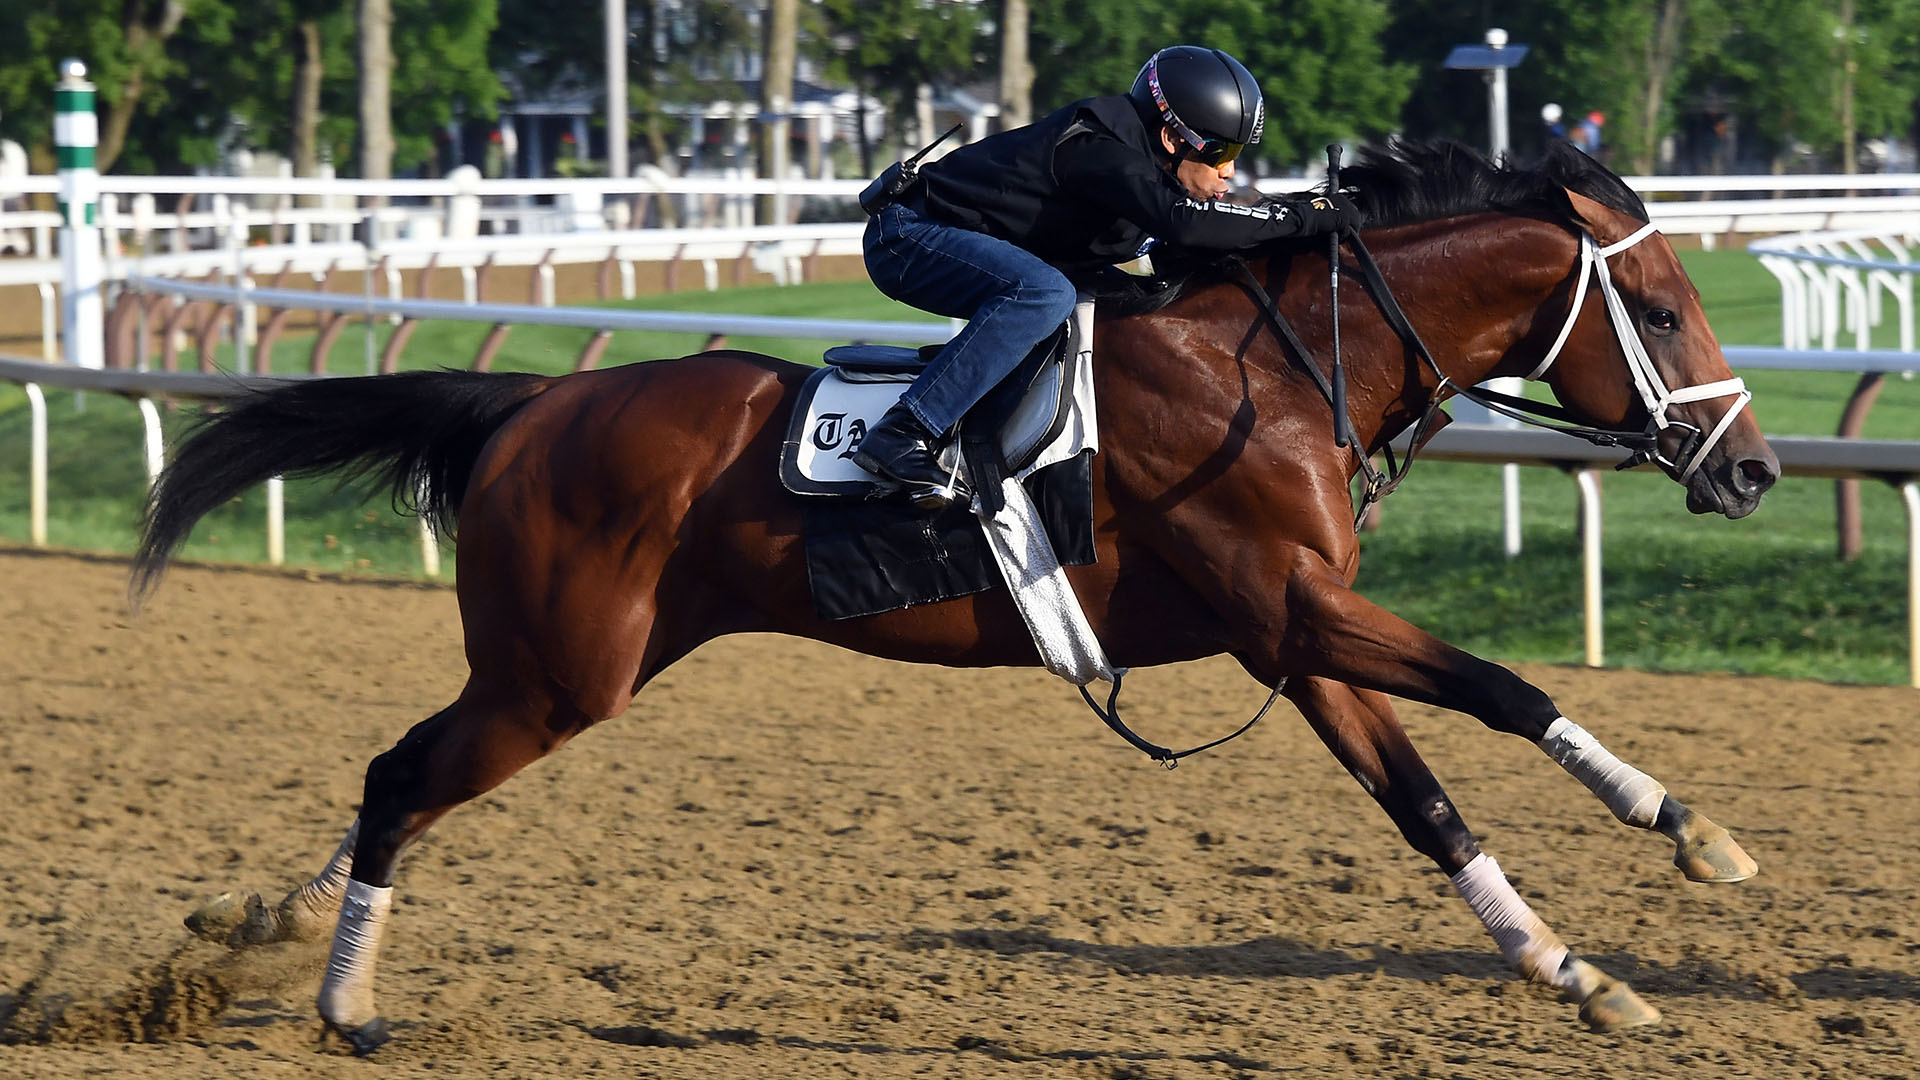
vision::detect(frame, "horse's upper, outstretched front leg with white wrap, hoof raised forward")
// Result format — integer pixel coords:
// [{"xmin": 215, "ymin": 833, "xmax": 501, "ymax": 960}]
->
[{"xmin": 1281, "ymin": 565, "xmax": 1759, "ymax": 882}]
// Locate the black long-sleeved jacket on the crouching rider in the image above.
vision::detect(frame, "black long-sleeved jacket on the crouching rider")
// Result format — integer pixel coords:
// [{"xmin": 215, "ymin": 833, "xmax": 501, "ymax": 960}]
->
[{"xmin": 906, "ymin": 96, "xmax": 1323, "ymax": 271}]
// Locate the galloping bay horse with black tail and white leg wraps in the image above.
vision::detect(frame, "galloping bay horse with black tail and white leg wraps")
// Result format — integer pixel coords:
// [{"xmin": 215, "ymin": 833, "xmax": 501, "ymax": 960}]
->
[{"xmin": 132, "ymin": 142, "xmax": 1780, "ymax": 1053}]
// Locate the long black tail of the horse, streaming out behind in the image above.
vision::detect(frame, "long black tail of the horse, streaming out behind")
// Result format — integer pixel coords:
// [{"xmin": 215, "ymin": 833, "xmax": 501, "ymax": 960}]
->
[{"xmin": 132, "ymin": 371, "xmax": 547, "ymax": 600}]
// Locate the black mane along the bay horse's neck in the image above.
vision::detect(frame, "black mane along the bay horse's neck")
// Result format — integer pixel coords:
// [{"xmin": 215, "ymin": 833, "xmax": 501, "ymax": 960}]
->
[{"xmin": 1081, "ymin": 138, "xmax": 1647, "ymax": 315}]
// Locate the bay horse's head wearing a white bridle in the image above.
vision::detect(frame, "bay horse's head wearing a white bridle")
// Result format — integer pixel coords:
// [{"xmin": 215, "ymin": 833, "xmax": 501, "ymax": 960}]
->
[{"xmin": 1536, "ymin": 192, "xmax": 1780, "ymax": 517}]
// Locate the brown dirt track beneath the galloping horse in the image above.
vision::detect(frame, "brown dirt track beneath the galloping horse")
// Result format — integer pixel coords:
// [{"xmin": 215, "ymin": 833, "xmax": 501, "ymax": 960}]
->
[{"xmin": 0, "ymin": 550, "xmax": 1920, "ymax": 1080}]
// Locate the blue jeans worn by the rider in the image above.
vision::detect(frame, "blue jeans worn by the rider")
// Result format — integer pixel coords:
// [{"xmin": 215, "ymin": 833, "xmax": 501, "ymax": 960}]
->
[{"xmin": 866, "ymin": 204, "xmax": 1077, "ymax": 434}]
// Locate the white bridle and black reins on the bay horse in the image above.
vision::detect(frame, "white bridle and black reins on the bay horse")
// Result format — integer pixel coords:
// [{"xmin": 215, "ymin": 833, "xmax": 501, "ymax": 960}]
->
[{"xmin": 1229, "ymin": 213, "xmax": 1753, "ymax": 532}]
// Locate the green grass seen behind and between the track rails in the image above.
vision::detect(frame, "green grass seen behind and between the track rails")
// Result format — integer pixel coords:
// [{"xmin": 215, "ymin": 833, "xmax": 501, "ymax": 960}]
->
[{"xmin": 0, "ymin": 252, "xmax": 1920, "ymax": 682}]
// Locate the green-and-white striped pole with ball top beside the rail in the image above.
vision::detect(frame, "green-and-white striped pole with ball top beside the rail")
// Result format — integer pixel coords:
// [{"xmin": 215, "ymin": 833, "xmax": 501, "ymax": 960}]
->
[{"xmin": 54, "ymin": 58, "xmax": 106, "ymax": 367}]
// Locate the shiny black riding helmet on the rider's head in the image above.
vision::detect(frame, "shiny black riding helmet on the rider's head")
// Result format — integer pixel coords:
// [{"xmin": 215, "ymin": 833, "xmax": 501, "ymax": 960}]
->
[{"xmin": 1127, "ymin": 44, "xmax": 1267, "ymax": 165}]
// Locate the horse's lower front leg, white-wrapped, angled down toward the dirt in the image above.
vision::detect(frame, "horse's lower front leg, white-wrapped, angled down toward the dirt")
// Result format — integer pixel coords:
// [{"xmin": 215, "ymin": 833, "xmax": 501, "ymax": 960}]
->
[{"xmin": 1286, "ymin": 678, "xmax": 1661, "ymax": 1030}]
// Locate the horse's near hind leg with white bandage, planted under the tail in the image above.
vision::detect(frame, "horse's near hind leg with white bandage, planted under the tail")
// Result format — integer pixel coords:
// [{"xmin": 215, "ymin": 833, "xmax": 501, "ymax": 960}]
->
[{"xmin": 319, "ymin": 684, "xmax": 591, "ymax": 1053}]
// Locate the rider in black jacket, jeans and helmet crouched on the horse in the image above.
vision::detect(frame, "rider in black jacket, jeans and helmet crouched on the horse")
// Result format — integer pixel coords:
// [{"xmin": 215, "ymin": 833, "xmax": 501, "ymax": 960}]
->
[{"xmin": 852, "ymin": 44, "xmax": 1359, "ymax": 509}]
